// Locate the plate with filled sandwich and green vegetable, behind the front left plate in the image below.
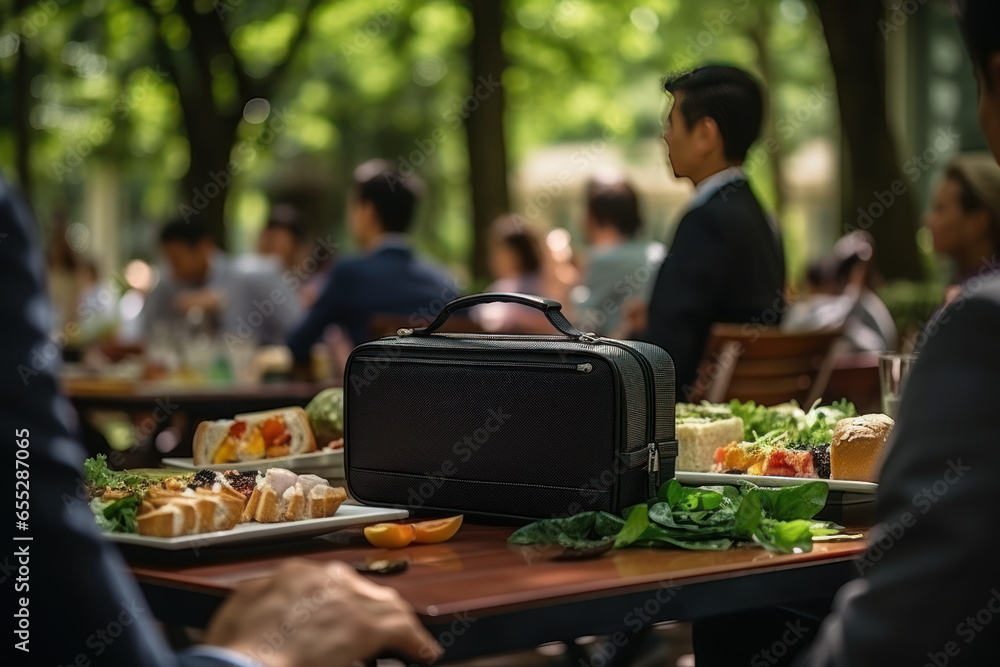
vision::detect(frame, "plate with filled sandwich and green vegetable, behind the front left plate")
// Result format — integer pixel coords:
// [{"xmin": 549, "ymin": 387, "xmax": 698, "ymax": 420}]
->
[{"xmin": 163, "ymin": 387, "xmax": 344, "ymax": 479}]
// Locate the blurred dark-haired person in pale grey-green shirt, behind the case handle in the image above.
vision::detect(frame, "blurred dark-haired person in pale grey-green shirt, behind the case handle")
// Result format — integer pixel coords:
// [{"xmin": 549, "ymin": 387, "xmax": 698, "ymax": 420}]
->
[{"xmin": 574, "ymin": 173, "xmax": 666, "ymax": 337}]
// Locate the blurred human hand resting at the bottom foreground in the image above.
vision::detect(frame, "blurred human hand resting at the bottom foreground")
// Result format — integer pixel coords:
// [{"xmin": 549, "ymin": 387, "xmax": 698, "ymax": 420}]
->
[{"xmin": 204, "ymin": 559, "xmax": 443, "ymax": 667}]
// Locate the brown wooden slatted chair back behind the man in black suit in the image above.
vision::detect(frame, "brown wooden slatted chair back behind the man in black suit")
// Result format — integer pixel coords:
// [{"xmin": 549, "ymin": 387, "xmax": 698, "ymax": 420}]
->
[{"xmin": 690, "ymin": 324, "xmax": 842, "ymax": 409}]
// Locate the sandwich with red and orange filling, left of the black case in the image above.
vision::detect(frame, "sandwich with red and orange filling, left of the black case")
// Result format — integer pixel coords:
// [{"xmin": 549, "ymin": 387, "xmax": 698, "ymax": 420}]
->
[{"xmin": 193, "ymin": 407, "xmax": 316, "ymax": 466}]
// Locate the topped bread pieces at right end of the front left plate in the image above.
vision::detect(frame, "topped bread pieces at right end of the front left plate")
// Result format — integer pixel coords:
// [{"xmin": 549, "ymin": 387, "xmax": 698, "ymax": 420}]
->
[{"xmin": 243, "ymin": 468, "xmax": 347, "ymax": 523}]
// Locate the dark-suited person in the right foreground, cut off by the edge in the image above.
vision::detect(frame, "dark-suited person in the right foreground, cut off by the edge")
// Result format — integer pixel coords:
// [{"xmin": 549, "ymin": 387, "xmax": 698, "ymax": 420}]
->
[{"xmin": 694, "ymin": 0, "xmax": 1000, "ymax": 667}]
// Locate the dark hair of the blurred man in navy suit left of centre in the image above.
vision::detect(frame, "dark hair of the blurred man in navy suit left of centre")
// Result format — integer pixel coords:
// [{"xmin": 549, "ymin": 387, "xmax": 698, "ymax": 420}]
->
[{"xmin": 354, "ymin": 160, "xmax": 424, "ymax": 234}]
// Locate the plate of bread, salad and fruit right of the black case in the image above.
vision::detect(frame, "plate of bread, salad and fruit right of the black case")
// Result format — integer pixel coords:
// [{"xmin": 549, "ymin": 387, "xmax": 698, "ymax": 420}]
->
[{"xmin": 677, "ymin": 401, "xmax": 893, "ymax": 494}]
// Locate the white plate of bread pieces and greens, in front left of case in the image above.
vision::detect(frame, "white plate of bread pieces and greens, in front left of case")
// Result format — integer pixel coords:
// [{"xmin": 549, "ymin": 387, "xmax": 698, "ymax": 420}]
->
[{"xmin": 84, "ymin": 455, "xmax": 408, "ymax": 551}]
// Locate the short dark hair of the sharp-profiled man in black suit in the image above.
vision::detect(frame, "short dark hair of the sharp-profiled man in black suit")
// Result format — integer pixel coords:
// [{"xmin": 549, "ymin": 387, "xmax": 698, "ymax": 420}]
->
[{"xmin": 662, "ymin": 65, "xmax": 764, "ymax": 160}]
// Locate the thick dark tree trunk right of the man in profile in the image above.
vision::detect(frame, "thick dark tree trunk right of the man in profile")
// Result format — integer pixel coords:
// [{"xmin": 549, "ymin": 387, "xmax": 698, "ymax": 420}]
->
[{"xmin": 816, "ymin": 0, "xmax": 923, "ymax": 280}]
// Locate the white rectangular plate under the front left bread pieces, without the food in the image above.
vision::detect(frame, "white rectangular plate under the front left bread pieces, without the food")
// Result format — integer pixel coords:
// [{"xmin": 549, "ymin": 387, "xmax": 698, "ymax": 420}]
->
[{"xmin": 104, "ymin": 504, "xmax": 409, "ymax": 551}]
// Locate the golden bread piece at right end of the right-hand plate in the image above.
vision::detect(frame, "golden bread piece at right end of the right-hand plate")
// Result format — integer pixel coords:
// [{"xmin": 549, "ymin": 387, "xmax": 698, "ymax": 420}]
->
[{"xmin": 830, "ymin": 414, "xmax": 895, "ymax": 482}]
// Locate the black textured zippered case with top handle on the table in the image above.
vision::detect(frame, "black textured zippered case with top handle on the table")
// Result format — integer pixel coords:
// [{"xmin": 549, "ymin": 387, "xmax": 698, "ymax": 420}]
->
[{"xmin": 344, "ymin": 293, "xmax": 677, "ymax": 520}]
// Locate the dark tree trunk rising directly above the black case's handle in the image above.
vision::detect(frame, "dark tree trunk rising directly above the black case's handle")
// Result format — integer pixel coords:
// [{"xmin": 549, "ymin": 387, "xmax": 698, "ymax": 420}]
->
[{"xmin": 463, "ymin": 0, "xmax": 509, "ymax": 279}]
